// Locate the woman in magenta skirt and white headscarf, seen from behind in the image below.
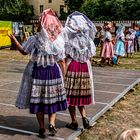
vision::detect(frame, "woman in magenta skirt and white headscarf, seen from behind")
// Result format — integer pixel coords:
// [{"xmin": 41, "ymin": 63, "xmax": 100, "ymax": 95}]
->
[{"xmin": 64, "ymin": 11, "xmax": 96, "ymax": 130}]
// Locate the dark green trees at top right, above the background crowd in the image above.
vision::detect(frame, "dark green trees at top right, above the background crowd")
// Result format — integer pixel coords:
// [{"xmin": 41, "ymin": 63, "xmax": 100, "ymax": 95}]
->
[{"xmin": 81, "ymin": 0, "xmax": 140, "ymax": 20}]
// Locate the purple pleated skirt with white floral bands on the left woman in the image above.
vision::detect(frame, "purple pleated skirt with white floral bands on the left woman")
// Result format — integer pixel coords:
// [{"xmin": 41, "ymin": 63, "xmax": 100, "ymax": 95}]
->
[{"xmin": 30, "ymin": 63, "xmax": 67, "ymax": 114}]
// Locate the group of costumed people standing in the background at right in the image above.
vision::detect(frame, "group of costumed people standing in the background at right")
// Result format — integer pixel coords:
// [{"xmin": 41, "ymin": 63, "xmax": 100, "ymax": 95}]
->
[{"xmin": 94, "ymin": 22, "xmax": 140, "ymax": 66}]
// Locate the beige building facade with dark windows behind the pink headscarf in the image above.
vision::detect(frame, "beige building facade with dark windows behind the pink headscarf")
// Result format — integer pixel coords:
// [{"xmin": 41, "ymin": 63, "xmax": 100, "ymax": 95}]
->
[{"xmin": 26, "ymin": 0, "xmax": 66, "ymax": 17}]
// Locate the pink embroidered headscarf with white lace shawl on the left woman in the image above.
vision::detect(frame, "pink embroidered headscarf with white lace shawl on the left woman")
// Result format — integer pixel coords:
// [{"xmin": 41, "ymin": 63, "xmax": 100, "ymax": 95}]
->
[{"xmin": 28, "ymin": 9, "xmax": 65, "ymax": 67}]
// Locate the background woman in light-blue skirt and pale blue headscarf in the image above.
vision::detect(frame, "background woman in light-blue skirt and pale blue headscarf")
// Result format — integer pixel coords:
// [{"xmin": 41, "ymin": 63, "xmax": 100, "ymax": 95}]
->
[{"xmin": 114, "ymin": 24, "xmax": 125, "ymax": 64}]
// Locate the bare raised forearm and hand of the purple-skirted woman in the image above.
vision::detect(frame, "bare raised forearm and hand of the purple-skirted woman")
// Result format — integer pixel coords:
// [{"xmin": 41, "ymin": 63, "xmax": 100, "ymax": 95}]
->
[{"xmin": 8, "ymin": 34, "xmax": 27, "ymax": 55}]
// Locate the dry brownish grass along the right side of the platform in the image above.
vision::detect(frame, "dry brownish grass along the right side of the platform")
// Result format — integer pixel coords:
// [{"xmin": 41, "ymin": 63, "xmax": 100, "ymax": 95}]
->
[{"xmin": 79, "ymin": 49, "xmax": 140, "ymax": 140}]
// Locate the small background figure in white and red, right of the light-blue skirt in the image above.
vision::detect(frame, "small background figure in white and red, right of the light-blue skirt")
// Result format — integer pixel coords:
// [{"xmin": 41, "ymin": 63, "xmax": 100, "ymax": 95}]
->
[{"xmin": 125, "ymin": 28, "xmax": 136, "ymax": 57}]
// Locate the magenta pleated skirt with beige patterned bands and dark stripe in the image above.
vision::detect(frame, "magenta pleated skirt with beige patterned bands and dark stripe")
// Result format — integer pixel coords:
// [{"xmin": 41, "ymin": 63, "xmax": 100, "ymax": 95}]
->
[{"xmin": 65, "ymin": 60, "xmax": 92, "ymax": 106}]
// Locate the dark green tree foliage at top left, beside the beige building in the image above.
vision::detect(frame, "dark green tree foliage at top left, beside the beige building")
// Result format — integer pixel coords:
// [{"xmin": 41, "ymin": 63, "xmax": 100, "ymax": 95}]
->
[{"xmin": 0, "ymin": 0, "xmax": 33, "ymax": 21}]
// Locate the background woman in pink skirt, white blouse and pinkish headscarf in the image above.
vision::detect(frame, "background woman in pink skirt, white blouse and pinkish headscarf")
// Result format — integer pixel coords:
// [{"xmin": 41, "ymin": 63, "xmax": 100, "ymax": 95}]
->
[{"xmin": 100, "ymin": 22, "xmax": 114, "ymax": 66}]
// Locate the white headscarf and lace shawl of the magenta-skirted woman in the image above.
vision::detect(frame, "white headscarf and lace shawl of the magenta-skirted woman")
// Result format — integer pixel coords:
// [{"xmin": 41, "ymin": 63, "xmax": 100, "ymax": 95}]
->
[{"xmin": 64, "ymin": 11, "xmax": 97, "ymax": 62}]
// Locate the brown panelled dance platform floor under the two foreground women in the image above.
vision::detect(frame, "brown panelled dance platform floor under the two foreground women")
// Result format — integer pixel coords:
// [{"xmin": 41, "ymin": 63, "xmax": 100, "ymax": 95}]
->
[{"xmin": 0, "ymin": 60, "xmax": 140, "ymax": 140}]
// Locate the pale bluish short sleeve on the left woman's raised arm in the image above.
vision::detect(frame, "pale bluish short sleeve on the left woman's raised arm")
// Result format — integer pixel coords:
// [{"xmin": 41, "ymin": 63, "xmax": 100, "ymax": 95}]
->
[{"xmin": 23, "ymin": 36, "xmax": 36, "ymax": 54}]
